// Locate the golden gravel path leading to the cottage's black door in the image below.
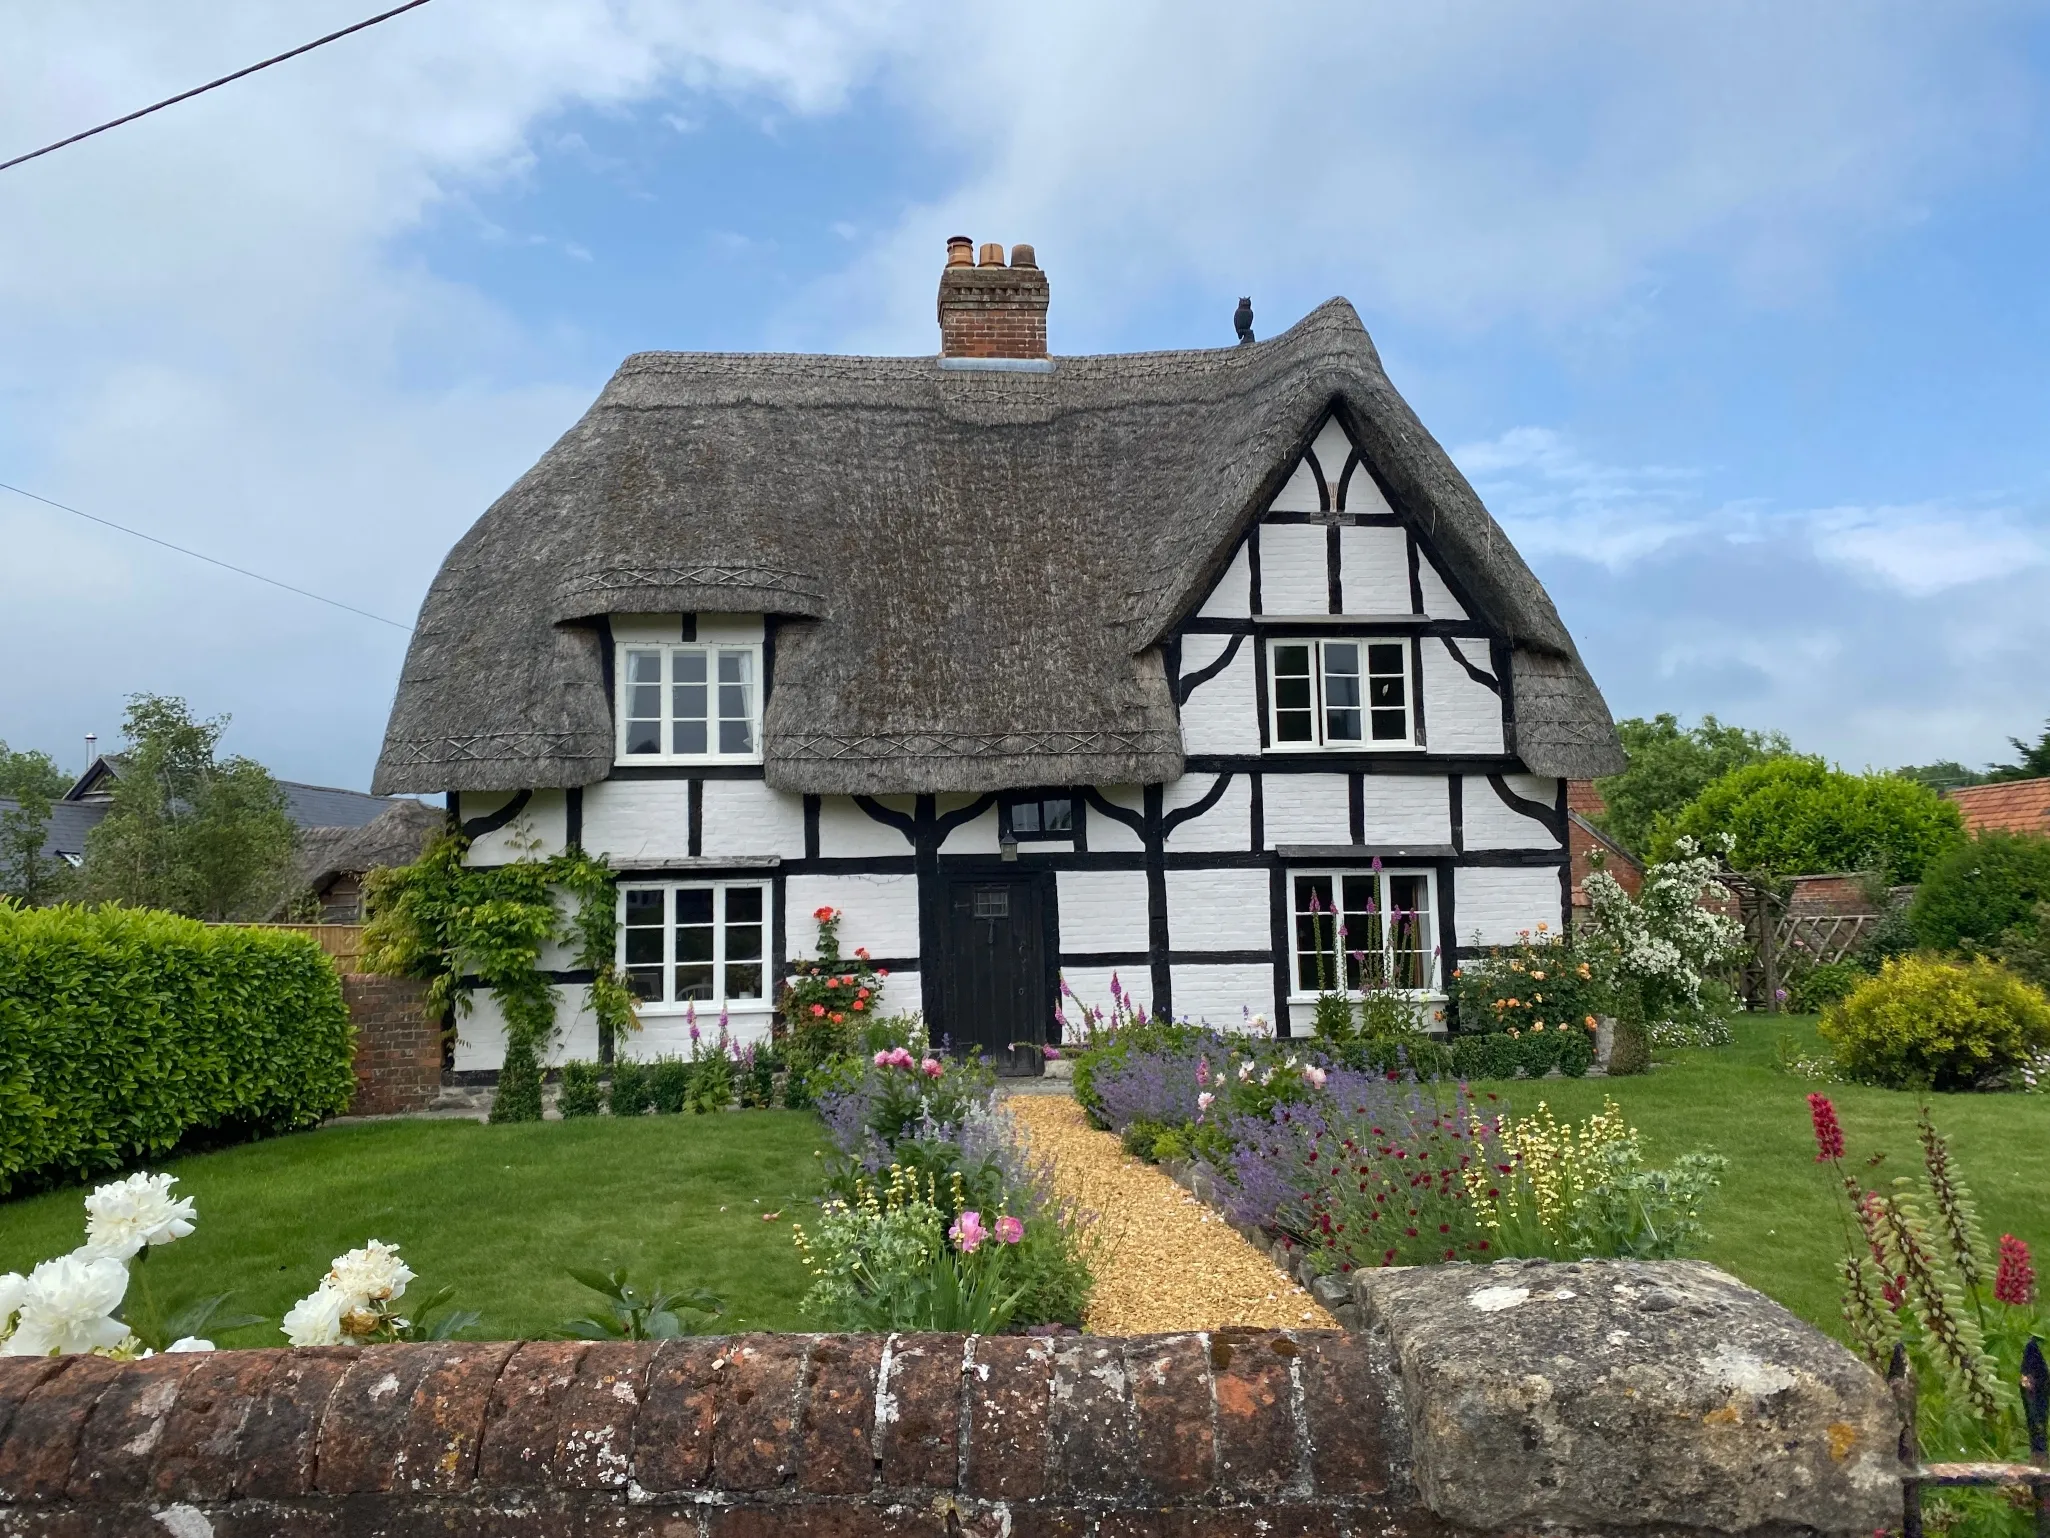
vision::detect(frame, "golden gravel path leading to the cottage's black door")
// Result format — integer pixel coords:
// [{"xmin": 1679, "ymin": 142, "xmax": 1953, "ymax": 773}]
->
[{"xmin": 1005, "ymin": 1095, "xmax": 1337, "ymax": 1335}]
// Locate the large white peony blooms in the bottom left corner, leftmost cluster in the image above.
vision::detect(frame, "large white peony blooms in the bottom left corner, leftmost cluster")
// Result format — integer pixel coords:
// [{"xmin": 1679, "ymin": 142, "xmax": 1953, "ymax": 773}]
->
[{"xmin": 0, "ymin": 1173, "xmax": 258, "ymax": 1360}]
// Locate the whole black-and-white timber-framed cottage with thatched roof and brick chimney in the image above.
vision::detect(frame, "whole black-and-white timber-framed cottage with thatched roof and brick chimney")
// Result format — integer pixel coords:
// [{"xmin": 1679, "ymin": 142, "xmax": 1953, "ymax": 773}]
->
[{"xmin": 375, "ymin": 240, "xmax": 1624, "ymax": 1070}]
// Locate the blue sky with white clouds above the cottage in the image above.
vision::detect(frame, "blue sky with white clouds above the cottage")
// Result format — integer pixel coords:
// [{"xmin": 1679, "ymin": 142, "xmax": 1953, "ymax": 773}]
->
[{"xmin": 0, "ymin": 0, "xmax": 2050, "ymax": 785}]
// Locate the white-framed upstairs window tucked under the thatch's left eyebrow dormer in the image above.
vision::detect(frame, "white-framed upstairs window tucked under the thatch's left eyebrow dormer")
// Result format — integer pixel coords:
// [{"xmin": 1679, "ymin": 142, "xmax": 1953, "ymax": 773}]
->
[{"xmin": 619, "ymin": 642, "xmax": 763, "ymax": 763}]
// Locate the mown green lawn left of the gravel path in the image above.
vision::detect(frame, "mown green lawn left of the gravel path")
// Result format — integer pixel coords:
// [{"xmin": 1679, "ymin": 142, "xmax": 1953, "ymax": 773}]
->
[{"xmin": 0, "ymin": 1111, "xmax": 826, "ymax": 1345}]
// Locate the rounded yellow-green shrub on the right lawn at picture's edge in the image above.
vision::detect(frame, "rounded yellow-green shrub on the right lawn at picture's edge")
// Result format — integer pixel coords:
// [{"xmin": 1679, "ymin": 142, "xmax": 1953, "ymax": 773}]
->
[{"xmin": 1822, "ymin": 956, "xmax": 2050, "ymax": 1091}]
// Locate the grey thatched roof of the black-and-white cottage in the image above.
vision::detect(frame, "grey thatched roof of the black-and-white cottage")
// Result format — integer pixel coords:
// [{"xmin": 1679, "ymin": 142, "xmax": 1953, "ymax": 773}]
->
[{"xmin": 375, "ymin": 299, "xmax": 1624, "ymax": 794}]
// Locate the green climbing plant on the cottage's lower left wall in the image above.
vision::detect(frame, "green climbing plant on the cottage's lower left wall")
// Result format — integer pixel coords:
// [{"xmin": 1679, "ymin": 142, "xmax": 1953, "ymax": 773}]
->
[{"xmin": 363, "ymin": 833, "xmax": 640, "ymax": 1122}]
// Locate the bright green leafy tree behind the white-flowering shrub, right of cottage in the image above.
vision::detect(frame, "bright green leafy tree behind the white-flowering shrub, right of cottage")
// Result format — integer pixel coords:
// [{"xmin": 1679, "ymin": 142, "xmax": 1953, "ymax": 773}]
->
[{"xmin": 1652, "ymin": 757, "xmax": 1964, "ymax": 882}]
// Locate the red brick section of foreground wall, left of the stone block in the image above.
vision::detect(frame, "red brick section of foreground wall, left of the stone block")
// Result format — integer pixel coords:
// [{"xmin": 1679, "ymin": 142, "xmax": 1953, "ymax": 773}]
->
[{"xmin": 0, "ymin": 1333, "xmax": 1441, "ymax": 1538}]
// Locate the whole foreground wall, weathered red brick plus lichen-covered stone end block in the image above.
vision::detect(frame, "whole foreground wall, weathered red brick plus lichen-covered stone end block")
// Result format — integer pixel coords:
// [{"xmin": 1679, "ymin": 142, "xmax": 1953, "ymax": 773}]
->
[{"xmin": 0, "ymin": 1263, "xmax": 1898, "ymax": 1538}]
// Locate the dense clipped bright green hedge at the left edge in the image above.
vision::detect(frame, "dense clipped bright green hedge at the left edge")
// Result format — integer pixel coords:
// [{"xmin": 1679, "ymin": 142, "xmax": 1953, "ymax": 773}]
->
[{"xmin": 0, "ymin": 904, "xmax": 355, "ymax": 1191}]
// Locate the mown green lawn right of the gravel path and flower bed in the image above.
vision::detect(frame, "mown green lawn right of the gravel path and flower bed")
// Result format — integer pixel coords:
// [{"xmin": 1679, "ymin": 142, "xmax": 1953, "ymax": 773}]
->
[{"xmin": 1480, "ymin": 1015, "xmax": 2050, "ymax": 1333}]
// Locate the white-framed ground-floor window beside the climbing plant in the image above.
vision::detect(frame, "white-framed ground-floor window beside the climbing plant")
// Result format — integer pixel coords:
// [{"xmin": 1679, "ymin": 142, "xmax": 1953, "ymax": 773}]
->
[{"xmin": 619, "ymin": 882, "xmax": 769, "ymax": 1005}]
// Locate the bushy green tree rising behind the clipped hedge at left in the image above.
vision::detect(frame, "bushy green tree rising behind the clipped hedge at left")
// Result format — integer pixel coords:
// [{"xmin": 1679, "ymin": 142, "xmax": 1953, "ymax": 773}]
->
[{"xmin": 80, "ymin": 695, "xmax": 297, "ymax": 921}]
